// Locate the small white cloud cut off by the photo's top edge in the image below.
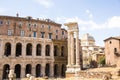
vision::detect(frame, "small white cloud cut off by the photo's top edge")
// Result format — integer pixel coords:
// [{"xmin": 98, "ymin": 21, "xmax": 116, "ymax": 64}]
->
[{"xmin": 35, "ymin": 0, "xmax": 54, "ymax": 8}]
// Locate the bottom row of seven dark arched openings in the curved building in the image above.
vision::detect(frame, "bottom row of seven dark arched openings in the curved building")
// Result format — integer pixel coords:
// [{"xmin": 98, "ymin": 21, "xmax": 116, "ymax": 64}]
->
[{"xmin": 3, "ymin": 63, "xmax": 66, "ymax": 79}]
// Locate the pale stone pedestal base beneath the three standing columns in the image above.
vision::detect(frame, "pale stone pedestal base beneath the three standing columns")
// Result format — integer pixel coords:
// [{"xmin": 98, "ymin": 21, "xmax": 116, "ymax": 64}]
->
[{"xmin": 66, "ymin": 65, "xmax": 81, "ymax": 77}]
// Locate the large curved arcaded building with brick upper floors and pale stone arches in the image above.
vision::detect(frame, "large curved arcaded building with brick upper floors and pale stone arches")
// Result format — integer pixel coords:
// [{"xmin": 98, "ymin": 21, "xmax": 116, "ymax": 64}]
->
[{"xmin": 0, "ymin": 15, "xmax": 67, "ymax": 80}]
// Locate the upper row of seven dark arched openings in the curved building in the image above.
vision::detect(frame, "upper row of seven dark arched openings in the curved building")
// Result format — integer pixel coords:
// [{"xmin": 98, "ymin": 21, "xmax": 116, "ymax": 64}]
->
[{"xmin": 4, "ymin": 42, "xmax": 65, "ymax": 56}]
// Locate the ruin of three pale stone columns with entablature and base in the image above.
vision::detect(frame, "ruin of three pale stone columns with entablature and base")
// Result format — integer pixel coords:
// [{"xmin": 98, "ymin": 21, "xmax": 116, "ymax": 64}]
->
[{"xmin": 64, "ymin": 22, "xmax": 81, "ymax": 77}]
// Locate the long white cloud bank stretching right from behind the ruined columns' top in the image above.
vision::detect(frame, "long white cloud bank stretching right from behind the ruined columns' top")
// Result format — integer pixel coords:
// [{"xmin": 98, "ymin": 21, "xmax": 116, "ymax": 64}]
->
[{"xmin": 57, "ymin": 16, "xmax": 120, "ymax": 30}]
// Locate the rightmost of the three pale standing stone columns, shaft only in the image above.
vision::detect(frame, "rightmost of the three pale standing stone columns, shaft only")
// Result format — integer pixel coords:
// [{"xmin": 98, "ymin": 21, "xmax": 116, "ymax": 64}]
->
[{"xmin": 76, "ymin": 31, "xmax": 80, "ymax": 66}]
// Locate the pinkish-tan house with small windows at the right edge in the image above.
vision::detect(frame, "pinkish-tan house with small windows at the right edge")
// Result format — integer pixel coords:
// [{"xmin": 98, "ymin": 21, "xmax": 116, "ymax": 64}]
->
[{"xmin": 104, "ymin": 36, "xmax": 120, "ymax": 67}]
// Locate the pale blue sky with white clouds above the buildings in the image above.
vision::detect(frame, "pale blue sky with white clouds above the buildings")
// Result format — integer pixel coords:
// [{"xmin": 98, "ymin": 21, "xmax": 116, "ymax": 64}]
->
[{"xmin": 0, "ymin": 0, "xmax": 120, "ymax": 46}]
